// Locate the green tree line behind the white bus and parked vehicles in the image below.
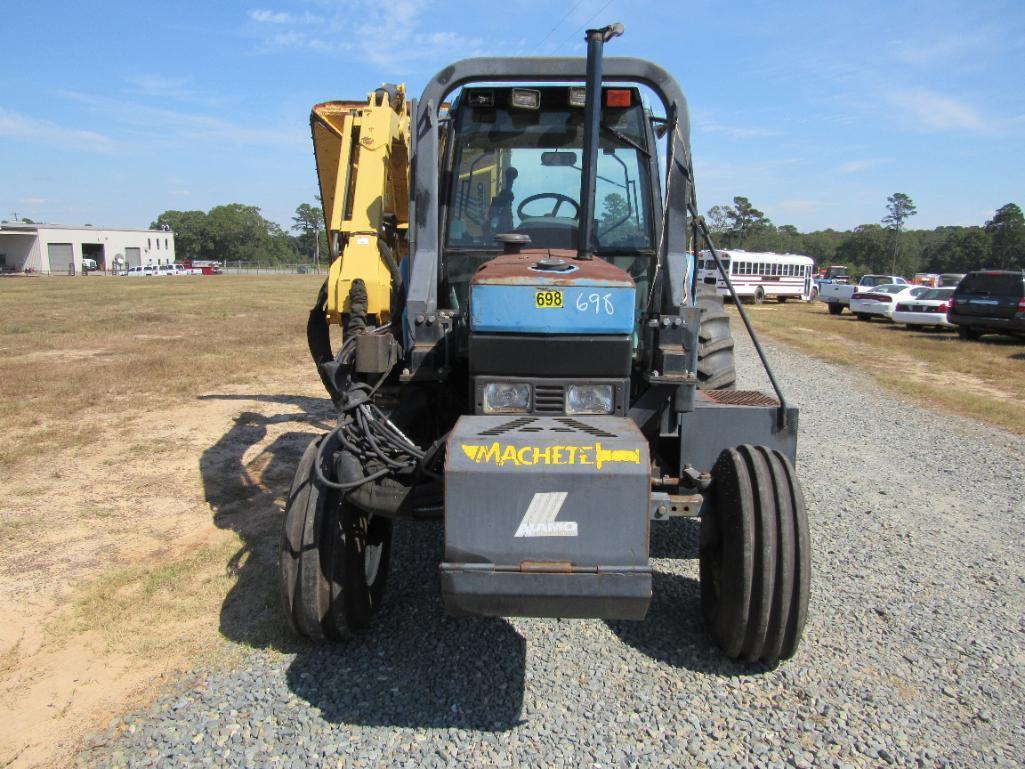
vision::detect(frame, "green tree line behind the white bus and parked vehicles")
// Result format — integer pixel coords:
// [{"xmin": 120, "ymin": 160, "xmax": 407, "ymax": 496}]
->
[{"xmin": 705, "ymin": 193, "xmax": 1025, "ymax": 276}]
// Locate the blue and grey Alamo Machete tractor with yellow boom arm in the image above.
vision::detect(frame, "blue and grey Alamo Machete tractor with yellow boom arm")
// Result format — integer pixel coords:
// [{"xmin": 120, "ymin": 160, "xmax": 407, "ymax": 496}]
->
[{"xmin": 279, "ymin": 25, "xmax": 811, "ymax": 665}]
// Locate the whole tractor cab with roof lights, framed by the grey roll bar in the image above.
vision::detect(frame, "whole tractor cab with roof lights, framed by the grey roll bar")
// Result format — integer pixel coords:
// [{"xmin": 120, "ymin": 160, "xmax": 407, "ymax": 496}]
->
[{"xmin": 441, "ymin": 85, "xmax": 659, "ymax": 326}]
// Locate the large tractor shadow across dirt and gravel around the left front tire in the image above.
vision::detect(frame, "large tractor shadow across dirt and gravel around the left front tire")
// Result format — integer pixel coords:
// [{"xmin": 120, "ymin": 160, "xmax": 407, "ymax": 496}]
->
[{"xmin": 199, "ymin": 395, "xmax": 526, "ymax": 731}]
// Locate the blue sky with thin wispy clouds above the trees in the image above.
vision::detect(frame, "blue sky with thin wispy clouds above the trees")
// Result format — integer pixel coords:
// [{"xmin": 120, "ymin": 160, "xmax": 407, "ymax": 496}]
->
[{"xmin": 0, "ymin": 0, "xmax": 1025, "ymax": 230}]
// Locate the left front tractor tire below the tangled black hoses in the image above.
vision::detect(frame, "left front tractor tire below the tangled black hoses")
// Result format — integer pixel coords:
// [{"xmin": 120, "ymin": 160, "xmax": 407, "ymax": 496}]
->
[{"xmin": 278, "ymin": 438, "xmax": 392, "ymax": 642}]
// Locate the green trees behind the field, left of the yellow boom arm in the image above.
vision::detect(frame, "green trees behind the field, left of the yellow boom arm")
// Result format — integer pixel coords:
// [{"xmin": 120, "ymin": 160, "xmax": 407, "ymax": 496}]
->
[{"xmin": 150, "ymin": 203, "xmax": 327, "ymax": 265}]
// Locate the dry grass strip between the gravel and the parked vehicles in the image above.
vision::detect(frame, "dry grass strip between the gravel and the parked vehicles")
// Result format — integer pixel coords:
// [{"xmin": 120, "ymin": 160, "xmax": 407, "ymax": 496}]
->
[{"xmin": 731, "ymin": 301, "xmax": 1025, "ymax": 435}]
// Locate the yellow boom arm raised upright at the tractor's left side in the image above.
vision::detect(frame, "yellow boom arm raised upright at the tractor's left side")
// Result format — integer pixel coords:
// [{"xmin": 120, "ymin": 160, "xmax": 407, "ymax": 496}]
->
[{"xmin": 310, "ymin": 85, "xmax": 409, "ymax": 324}]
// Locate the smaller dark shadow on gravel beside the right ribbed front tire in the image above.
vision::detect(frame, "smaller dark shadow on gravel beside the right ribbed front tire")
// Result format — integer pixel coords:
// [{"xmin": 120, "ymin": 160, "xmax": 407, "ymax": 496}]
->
[{"xmin": 606, "ymin": 518, "xmax": 772, "ymax": 678}]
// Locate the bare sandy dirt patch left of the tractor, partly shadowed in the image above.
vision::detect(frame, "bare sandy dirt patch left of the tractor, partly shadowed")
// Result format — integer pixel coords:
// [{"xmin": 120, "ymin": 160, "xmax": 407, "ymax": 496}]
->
[{"xmin": 0, "ymin": 371, "xmax": 330, "ymax": 767}]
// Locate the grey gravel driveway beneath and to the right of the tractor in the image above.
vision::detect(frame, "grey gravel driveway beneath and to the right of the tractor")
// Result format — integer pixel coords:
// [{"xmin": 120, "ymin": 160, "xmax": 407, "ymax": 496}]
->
[{"xmin": 79, "ymin": 334, "xmax": 1025, "ymax": 767}]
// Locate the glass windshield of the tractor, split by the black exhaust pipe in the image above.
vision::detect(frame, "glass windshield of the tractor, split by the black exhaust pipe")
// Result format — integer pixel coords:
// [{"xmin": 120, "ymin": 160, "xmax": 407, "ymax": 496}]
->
[{"xmin": 446, "ymin": 87, "xmax": 653, "ymax": 254}]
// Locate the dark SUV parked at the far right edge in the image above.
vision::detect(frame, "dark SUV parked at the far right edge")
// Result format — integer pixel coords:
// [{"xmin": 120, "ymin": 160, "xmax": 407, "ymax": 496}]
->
[{"xmin": 947, "ymin": 270, "xmax": 1025, "ymax": 339}]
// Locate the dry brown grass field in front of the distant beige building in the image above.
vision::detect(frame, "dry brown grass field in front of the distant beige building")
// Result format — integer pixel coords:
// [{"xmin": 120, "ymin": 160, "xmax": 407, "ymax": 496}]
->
[{"xmin": 0, "ymin": 276, "xmax": 322, "ymax": 467}]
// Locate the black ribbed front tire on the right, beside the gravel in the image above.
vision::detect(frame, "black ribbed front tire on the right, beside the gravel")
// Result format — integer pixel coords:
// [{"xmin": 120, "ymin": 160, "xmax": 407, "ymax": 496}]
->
[{"xmin": 700, "ymin": 445, "xmax": 811, "ymax": 665}]
